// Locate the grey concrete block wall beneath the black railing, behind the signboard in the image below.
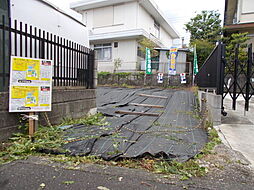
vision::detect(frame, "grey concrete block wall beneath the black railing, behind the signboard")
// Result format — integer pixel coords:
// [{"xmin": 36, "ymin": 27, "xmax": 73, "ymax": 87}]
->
[{"xmin": 0, "ymin": 88, "xmax": 96, "ymax": 141}]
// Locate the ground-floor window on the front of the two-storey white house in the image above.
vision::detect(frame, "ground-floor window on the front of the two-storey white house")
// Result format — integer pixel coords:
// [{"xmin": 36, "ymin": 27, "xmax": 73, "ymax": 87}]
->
[{"xmin": 94, "ymin": 43, "xmax": 112, "ymax": 61}]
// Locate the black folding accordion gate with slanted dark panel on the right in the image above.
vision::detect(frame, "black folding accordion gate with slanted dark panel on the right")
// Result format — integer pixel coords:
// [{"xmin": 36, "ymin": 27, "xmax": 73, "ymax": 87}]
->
[{"xmin": 196, "ymin": 43, "xmax": 254, "ymax": 113}]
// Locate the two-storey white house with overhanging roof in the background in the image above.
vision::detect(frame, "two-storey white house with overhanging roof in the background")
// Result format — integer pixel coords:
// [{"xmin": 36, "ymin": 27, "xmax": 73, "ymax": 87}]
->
[{"xmin": 71, "ymin": 0, "xmax": 179, "ymax": 72}]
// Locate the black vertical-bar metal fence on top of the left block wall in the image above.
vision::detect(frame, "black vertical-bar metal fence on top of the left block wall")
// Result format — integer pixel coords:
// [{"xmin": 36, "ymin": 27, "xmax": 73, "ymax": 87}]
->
[{"xmin": 0, "ymin": 16, "xmax": 94, "ymax": 91}]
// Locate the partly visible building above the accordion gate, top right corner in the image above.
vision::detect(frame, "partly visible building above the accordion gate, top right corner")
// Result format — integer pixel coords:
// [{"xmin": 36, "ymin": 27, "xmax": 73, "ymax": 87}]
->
[{"xmin": 224, "ymin": 0, "xmax": 254, "ymax": 46}]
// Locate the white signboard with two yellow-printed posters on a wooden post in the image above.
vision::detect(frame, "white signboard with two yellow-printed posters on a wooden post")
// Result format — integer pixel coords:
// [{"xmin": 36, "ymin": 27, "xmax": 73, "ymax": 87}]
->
[{"xmin": 9, "ymin": 56, "xmax": 53, "ymax": 112}]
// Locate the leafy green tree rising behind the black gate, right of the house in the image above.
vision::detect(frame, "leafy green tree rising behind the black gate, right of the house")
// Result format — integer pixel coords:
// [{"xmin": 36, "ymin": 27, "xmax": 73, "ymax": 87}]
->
[{"xmin": 185, "ymin": 10, "xmax": 222, "ymax": 43}]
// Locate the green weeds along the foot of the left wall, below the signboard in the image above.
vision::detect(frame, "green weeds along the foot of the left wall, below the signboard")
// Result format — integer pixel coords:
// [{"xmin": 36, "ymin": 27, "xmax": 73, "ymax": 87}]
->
[{"xmin": 0, "ymin": 114, "xmax": 108, "ymax": 164}]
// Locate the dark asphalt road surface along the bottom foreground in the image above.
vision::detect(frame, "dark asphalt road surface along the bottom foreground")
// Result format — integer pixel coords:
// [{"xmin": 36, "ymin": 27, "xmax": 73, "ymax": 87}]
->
[{"xmin": 0, "ymin": 153, "xmax": 254, "ymax": 190}]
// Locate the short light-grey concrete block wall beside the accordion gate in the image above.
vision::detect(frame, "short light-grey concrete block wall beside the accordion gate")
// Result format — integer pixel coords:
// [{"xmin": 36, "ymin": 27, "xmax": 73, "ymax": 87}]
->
[{"xmin": 198, "ymin": 91, "xmax": 222, "ymax": 126}]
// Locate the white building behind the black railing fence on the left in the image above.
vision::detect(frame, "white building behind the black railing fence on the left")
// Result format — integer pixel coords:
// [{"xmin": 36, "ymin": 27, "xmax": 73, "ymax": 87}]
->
[{"xmin": 0, "ymin": 0, "xmax": 89, "ymax": 91}]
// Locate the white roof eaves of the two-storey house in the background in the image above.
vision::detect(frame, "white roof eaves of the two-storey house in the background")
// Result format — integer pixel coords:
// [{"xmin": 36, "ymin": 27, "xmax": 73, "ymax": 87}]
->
[{"xmin": 70, "ymin": 0, "xmax": 179, "ymax": 39}]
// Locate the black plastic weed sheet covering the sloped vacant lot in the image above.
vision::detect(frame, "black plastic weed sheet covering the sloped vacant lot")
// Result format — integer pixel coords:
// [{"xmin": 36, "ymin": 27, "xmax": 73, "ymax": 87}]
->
[{"xmin": 64, "ymin": 87, "xmax": 207, "ymax": 161}]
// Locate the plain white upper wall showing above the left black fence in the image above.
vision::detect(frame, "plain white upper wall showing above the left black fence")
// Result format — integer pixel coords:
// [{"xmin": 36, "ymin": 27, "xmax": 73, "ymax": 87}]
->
[{"xmin": 11, "ymin": 0, "xmax": 89, "ymax": 47}]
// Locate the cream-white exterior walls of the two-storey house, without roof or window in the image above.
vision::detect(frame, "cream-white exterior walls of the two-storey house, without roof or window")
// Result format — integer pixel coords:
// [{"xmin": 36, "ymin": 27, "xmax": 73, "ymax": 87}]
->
[{"xmin": 76, "ymin": 1, "xmax": 177, "ymax": 72}]
